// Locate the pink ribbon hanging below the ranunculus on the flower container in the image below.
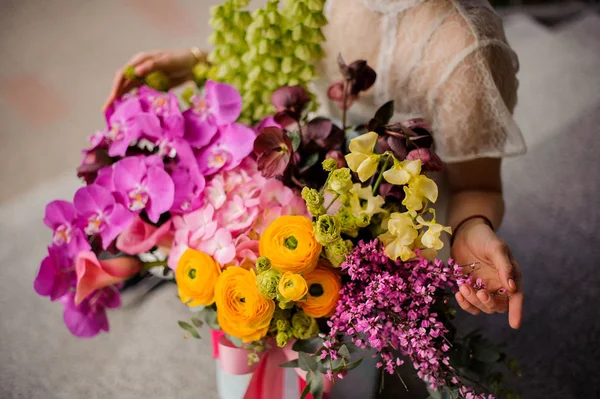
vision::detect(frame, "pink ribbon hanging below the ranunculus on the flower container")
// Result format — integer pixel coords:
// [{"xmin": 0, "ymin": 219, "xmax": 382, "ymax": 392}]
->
[{"xmin": 211, "ymin": 330, "xmax": 333, "ymax": 399}]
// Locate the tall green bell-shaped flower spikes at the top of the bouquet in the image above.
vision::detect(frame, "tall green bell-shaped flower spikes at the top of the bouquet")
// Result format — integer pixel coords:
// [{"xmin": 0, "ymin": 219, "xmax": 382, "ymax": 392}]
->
[{"xmin": 207, "ymin": 0, "xmax": 327, "ymax": 123}]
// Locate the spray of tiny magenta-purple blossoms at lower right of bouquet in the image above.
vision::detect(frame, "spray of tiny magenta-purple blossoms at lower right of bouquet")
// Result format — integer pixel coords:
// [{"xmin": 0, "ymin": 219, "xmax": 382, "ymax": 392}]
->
[{"xmin": 328, "ymin": 240, "xmax": 481, "ymax": 398}]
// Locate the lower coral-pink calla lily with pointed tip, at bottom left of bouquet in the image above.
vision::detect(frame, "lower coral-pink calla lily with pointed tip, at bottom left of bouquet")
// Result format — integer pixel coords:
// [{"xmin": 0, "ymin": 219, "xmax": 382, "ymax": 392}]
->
[{"xmin": 75, "ymin": 251, "xmax": 142, "ymax": 305}]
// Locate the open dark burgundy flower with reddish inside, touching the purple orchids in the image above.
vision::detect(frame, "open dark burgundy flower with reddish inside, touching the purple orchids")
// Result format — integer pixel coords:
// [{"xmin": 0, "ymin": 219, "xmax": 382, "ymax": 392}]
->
[{"xmin": 254, "ymin": 126, "xmax": 292, "ymax": 178}]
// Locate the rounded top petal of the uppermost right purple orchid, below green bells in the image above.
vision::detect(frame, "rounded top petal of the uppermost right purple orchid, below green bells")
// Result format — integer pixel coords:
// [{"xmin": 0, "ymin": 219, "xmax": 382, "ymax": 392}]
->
[{"xmin": 205, "ymin": 80, "xmax": 242, "ymax": 126}]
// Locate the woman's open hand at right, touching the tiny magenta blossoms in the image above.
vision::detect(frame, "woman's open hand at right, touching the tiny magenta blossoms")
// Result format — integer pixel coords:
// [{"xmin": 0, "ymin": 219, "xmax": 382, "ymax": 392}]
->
[{"xmin": 452, "ymin": 218, "xmax": 523, "ymax": 328}]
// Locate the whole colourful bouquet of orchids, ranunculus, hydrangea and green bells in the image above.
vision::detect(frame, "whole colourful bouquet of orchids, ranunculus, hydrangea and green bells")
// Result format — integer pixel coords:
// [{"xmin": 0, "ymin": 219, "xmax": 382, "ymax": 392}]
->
[{"xmin": 34, "ymin": 0, "xmax": 518, "ymax": 399}]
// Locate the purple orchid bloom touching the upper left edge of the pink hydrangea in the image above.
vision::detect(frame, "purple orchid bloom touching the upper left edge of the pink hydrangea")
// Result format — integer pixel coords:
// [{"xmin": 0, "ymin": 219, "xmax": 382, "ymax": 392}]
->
[{"xmin": 170, "ymin": 162, "xmax": 206, "ymax": 214}]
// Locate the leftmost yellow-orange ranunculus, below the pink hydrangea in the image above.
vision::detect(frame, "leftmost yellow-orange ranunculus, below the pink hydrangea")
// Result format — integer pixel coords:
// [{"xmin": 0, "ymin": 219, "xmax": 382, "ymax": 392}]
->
[{"xmin": 175, "ymin": 249, "xmax": 221, "ymax": 306}]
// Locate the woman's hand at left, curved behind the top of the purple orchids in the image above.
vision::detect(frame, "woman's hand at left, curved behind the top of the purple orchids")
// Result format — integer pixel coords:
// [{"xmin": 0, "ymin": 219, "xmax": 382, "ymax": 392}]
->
[{"xmin": 104, "ymin": 49, "xmax": 200, "ymax": 110}]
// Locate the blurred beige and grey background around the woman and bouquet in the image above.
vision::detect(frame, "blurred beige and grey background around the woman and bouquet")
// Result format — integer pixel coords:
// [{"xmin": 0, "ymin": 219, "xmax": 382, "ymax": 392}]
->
[{"xmin": 0, "ymin": 0, "xmax": 600, "ymax": 399}]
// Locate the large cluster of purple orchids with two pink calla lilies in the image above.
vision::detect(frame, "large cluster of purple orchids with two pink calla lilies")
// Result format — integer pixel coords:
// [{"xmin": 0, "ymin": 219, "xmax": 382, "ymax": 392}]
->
[{"xmin": 34, "ymin": 81, "xmax": 256, "ymax": 337}]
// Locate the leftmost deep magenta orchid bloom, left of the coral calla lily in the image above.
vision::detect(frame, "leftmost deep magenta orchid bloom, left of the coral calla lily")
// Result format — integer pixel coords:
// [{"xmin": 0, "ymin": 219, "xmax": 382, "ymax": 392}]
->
[{"xmin": 33, "ymin": 245, "xmax": 77, "ymax": 301}]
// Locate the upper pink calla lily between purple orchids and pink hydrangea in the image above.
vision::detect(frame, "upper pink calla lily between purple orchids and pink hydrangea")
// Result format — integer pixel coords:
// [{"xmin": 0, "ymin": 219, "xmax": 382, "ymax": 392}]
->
[{"xmin": 117, "ymin": 216, "xmax": 171, "ymax": 255}]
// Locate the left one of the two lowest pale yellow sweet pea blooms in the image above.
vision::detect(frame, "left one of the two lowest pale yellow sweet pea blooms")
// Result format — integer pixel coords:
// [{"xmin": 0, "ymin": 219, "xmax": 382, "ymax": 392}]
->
[{"xmin": 379, "ymin": 212, "xmax": 419, "ymax": 261}]
